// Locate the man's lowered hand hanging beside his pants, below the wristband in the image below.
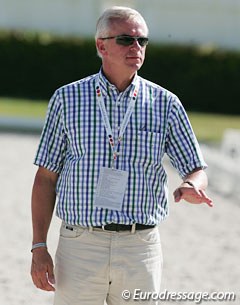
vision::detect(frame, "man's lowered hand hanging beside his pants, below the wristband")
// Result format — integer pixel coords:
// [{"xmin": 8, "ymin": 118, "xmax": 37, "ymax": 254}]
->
[{"xmin": 31, "ymin": 248, "xmax": 55, "ymax": 291}]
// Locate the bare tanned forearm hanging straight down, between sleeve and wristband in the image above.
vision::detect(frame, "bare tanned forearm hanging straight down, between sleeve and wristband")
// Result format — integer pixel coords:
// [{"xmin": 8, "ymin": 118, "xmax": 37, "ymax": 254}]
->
[{"xmin": 32, "ymin": 168, "xmax": 57, "ymax": 243}]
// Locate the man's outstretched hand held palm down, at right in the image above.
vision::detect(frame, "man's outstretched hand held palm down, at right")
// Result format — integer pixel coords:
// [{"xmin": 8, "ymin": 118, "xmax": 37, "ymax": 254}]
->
[{"xmin": 173, "ymin": 183, "xmax": 213, "ymax": 207}]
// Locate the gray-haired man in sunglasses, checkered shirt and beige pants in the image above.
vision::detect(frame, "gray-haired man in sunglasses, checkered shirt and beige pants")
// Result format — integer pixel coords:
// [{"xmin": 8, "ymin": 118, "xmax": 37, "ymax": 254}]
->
[{"xmin": 31, "ymin": 7, "xmax": 212, "ymax": 305}]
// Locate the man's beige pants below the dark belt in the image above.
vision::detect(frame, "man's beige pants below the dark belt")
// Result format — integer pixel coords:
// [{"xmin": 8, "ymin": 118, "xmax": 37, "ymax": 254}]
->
[{"xmin": 54, "ymin": 224, "xmax": 162, "ymax": 305}]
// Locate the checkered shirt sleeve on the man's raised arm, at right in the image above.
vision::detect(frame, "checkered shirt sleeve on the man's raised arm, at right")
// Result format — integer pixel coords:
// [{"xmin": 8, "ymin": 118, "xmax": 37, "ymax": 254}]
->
[{"xmin": 165, "ymin": 97, "xmax": 207, "ymax": 177}]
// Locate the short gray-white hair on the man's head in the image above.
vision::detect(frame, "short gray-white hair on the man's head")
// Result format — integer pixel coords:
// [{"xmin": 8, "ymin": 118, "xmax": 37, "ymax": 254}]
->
[{"xmin": 95, "ymin": 6, "xmax": 148, "ymax": 40}]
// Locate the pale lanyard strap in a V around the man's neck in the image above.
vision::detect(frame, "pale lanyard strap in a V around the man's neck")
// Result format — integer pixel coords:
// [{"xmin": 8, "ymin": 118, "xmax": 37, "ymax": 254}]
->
[{"xmin": 96, "ymin": 75, "xmax": 139, "ymax": 168}]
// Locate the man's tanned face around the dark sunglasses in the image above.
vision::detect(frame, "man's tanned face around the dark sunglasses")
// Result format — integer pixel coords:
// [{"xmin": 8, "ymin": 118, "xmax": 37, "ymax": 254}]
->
[{"xmin": 97, "ymin": 20, "xmax": 147, "ymax": 73}]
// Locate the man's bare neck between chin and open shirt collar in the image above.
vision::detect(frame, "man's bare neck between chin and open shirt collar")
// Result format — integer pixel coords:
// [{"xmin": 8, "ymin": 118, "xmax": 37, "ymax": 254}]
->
[{"xmin": 103, "ymin": 67, "xmax": 136, "ymax": 92}]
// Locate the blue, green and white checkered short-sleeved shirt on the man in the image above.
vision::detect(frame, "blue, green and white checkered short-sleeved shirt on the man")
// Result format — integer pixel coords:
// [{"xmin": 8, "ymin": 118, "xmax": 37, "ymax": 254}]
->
[{"xmin": 34, "ymin": 71, "xmax": 206, "ymax": 226}]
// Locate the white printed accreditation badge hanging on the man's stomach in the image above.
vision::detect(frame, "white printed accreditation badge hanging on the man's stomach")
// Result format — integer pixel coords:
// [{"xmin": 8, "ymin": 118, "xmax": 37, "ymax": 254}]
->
[{"xmin": 94, "ymin": 167, "xmax": 128, "ymax": 211}]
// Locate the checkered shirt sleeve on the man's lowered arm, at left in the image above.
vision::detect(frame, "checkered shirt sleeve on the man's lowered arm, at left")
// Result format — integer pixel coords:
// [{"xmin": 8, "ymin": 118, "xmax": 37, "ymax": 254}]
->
[{"xmin": 34, "ymin": 91, "xmax": 66, "ymax": 173}]
